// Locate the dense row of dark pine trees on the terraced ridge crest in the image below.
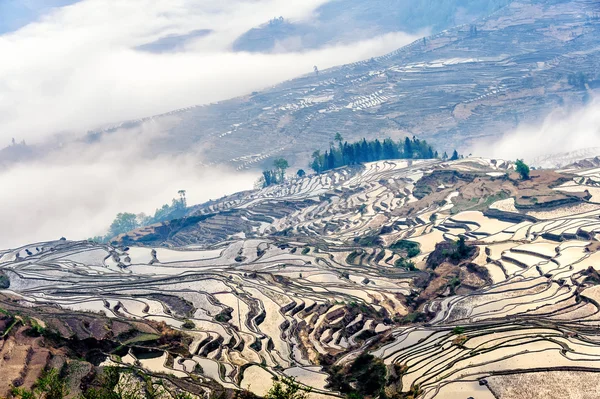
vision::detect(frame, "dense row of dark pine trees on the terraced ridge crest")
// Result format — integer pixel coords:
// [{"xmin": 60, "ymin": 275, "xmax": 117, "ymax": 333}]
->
[{"xmin": 310, "ymin": 133, "xmax": 458, "ymax": 173}]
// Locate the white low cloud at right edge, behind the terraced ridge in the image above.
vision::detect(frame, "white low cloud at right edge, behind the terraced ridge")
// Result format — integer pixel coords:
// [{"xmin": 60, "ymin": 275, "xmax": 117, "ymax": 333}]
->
[{"xmin": 470, "ymin": 98, "xmax": 600, "ymax": 166}]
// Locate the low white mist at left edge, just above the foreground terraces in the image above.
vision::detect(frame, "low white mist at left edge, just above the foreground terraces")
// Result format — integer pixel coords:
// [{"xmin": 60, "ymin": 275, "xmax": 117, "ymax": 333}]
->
[{"xmin": 0, "ymin": 122, "xmax": 258, "ymax": 248}]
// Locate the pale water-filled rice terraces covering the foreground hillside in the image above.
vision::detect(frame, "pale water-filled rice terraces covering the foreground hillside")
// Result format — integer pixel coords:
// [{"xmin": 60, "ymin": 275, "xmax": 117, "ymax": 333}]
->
[{"xmin": 0, "ymin": 158, "xmax": 600, "ymax": 399}]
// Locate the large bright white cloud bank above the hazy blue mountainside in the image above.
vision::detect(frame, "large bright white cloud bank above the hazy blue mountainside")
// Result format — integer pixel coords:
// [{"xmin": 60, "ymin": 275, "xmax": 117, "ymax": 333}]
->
[{"xmin": 0, "ymin": 0, "xmax": 424, "ymax": 143}]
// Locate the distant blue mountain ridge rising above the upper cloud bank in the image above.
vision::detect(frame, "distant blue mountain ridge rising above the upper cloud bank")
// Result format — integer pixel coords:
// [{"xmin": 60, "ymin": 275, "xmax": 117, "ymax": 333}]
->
[{"xmin": 234, "ymin": 0, "xmax": 511, "ymax": 51}]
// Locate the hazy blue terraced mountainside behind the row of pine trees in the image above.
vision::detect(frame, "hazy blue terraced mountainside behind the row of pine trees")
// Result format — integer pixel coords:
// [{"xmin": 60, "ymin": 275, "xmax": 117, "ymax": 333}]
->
[{"xmin": 132, "ymin": 0, "xmax": 600, "ymax": 168}]
